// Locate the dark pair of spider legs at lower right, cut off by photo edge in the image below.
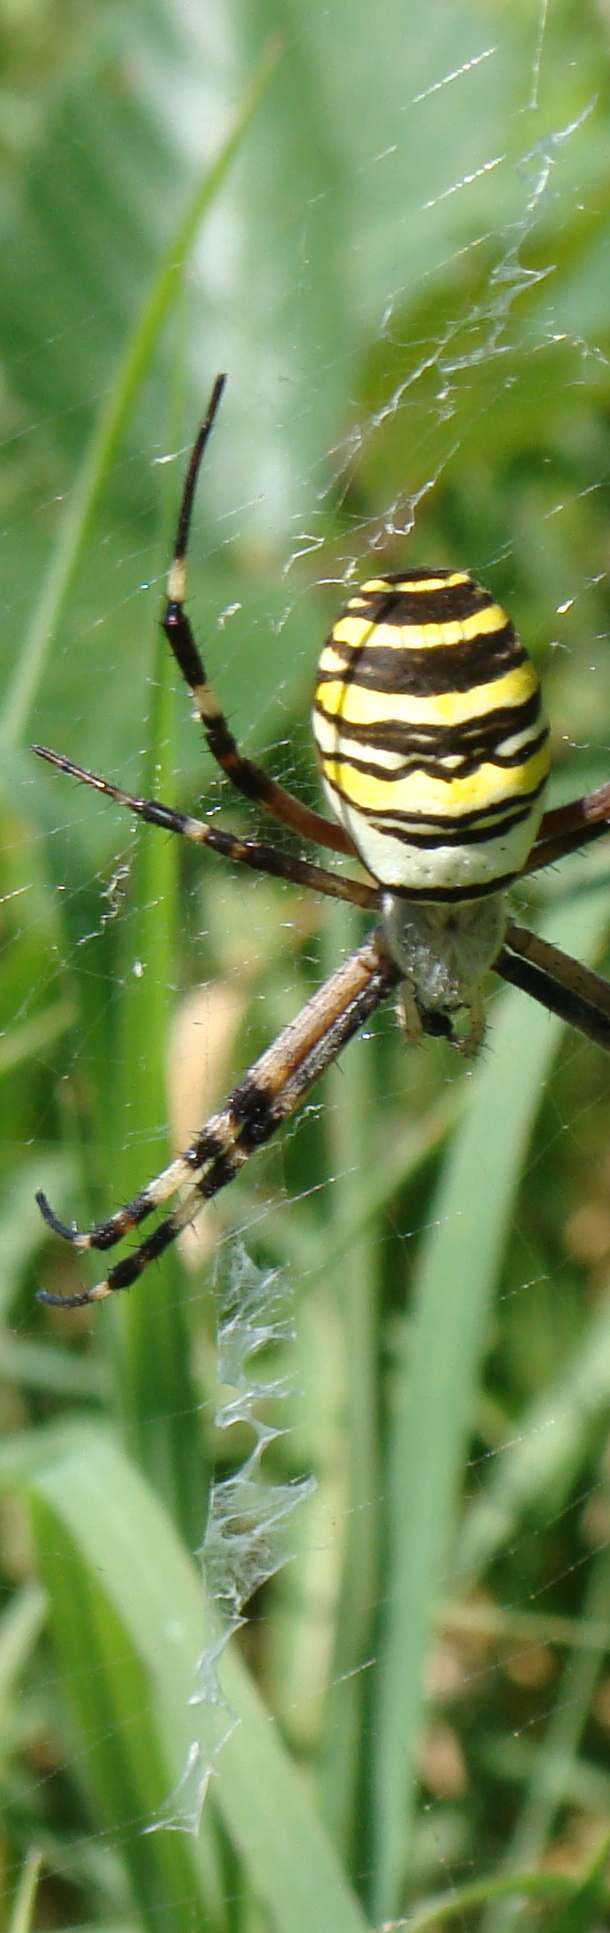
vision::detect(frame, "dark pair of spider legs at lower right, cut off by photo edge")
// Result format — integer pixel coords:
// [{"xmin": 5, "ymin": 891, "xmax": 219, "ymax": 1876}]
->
[{"xmin": 494, "ymin": 920, "xmax": 610, "ymax": 1053}]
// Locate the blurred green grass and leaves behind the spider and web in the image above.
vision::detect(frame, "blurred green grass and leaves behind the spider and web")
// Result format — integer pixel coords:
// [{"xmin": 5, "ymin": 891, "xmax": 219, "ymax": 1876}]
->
[{"xmin": 0, "ymin": 0, "xmax": 610, "ymax": 1933}]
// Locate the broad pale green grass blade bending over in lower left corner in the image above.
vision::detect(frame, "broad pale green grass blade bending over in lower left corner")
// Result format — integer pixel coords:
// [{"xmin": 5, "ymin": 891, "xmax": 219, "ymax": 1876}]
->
[{"xmin": 11, "ymin": 1428, "xmax": 365, "ymax": 1933}]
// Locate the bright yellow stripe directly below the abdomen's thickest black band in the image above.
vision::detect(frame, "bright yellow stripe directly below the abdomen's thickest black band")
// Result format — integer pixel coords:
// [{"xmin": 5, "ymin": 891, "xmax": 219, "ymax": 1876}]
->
[{"xmin": 317, "ymin": 659, "xmax": 539, "ymax": 731}]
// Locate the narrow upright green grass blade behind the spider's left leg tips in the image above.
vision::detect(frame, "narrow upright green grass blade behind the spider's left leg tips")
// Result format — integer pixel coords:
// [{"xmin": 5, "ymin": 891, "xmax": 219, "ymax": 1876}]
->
[{"xmin": 100, "ymin": 392, "xmax": 199, "ymax": 1523}]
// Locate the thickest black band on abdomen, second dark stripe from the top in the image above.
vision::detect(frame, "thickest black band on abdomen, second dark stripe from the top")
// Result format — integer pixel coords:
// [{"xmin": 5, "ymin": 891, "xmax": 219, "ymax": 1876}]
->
[{"xmin": 317, "ymin": 622, "xmax": 527, "ymax": 698}]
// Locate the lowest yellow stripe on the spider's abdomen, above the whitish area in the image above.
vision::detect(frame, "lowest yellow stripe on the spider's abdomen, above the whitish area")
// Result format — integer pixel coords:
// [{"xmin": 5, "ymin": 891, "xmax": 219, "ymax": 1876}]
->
[{"xmin": 322, "ymin": 744, "xmax": 550, "ymax": 820}]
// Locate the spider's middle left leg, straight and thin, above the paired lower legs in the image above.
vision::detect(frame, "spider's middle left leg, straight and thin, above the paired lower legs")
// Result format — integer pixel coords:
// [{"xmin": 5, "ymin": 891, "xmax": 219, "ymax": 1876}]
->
[{"xmin": 33, "ymin": 744, "xmax": 378, "ymax": 909}]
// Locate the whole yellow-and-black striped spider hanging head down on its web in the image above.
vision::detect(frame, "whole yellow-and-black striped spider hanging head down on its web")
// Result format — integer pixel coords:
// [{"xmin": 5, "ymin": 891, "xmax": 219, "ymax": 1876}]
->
[{"xmin": 33, "ymin": 375, "xmax": 610, "ymax": 1309}]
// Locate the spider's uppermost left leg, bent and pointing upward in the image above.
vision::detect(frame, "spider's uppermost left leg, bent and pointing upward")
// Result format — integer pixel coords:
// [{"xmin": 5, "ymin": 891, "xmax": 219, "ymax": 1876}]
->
[{"xmin": 162, "ymin": 375, "xmax": 355, "ymax": 854}]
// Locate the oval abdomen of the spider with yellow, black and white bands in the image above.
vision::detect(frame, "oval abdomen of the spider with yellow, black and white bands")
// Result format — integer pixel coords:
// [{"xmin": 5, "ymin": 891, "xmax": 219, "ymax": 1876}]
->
[{"xmin": 313, "ymin": 570, "xmax": 550, "ymax": 899}]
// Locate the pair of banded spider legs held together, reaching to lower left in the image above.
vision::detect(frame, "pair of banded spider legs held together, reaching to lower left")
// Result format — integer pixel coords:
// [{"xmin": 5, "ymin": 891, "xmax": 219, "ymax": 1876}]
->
[{"xmin": 37, "ymin": 932, "xmax": 398, "ymax": 1309}]
